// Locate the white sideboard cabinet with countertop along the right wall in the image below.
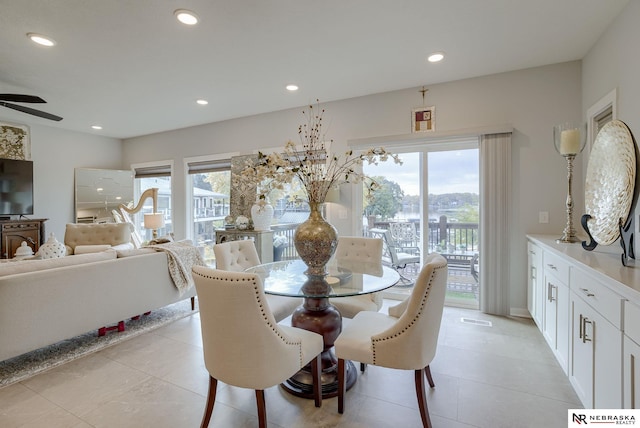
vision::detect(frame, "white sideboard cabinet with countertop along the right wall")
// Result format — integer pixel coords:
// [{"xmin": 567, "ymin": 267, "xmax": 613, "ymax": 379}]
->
[{"xmin": 527, "ymin": 235, "xmax": 640, "ymax": 409}]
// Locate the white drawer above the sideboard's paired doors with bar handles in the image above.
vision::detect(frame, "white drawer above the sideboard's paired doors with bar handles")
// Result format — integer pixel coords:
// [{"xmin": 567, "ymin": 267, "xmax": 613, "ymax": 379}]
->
[{"xmin": 569, "ymin": 268, "xmax": 624, "ymax": 329}]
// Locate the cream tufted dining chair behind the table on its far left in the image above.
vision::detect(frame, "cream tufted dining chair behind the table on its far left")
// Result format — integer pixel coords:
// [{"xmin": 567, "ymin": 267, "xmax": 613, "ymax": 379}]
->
[{"xmin": 213, "ymin": 239, "xmax": 302, "ymax": 322}]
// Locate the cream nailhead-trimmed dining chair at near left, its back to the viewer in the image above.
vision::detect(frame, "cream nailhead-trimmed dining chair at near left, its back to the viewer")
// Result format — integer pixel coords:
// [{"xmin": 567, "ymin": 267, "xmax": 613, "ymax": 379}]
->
[{"xmin": 192, "ymin": 266, "xmax": 324, "ymax": 428}]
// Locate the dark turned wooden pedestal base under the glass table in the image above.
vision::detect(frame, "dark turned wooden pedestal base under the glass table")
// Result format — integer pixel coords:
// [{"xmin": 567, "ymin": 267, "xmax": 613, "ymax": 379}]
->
[{"xmin": 282, "ymin": 297, "xmax": 358, "ymax": 398}]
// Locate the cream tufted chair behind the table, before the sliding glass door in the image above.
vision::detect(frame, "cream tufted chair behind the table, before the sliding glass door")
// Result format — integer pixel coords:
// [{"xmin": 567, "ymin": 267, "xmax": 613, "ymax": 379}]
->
[{"xmin": 330, "ymin": 236, "xmax": 382, "ymax": 318}]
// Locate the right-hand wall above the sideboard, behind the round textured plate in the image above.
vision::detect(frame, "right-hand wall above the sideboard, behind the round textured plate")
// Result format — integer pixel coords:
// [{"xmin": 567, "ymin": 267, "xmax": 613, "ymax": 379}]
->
[{"xmin": 582, "ymin": 1, "xmax": 640, "ymax": 257}]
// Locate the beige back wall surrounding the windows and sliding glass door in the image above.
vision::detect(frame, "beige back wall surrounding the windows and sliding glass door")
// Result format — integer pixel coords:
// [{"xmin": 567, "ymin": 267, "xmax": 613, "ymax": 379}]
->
[{"xmin": 124, "ymin": 61, "xmax": 584, "ymax": 313}]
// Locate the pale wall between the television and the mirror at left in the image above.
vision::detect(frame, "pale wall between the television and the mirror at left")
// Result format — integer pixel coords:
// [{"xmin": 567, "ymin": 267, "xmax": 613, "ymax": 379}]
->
[{"xmin": 11, "ymin": 122, "xmax": 122, "ymax": 241}]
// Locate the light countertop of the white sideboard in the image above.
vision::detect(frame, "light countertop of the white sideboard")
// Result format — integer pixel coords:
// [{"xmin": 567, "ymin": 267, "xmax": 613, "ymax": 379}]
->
[{"xmin": 527, "ymin": 235, "xmax": 640, "ymax": 304}]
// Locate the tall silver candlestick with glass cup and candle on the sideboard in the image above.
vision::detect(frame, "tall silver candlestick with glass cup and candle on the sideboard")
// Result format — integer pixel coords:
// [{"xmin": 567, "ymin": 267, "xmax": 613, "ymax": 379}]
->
[{"xmin": 553, "ymin": 122, "xmax": 587, "ymax": 244}]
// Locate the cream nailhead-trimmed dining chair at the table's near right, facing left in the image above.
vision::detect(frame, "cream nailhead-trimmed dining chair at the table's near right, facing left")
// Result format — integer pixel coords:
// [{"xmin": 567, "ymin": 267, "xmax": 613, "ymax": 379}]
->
[{"xmin": 334, "ymin": 253, "xmax": 447, "ymax": 427}]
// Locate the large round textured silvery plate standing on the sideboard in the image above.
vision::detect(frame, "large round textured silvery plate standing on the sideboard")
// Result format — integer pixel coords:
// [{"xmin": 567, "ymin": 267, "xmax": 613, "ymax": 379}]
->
[{"xmin": 584, "ymin": 120, "xmax": 636, "ymax": 245}]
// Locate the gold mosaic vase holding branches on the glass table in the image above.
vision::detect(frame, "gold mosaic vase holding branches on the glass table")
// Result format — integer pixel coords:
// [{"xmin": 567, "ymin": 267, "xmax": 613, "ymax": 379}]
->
[{"xmin": 293, "ymin": 202, "xmax": 338, "ymax": 275}]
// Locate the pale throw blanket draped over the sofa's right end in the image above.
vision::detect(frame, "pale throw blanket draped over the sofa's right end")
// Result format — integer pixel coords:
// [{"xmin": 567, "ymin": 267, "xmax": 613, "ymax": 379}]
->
[{"xmin": 147, "ymin": 240, "xmax": 207, "ymax": 295}]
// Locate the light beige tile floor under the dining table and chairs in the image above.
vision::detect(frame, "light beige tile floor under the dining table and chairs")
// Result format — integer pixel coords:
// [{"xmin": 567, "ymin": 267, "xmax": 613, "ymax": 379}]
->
[{"xmin": 0, "ymin": 302, "xmax": 581, "ymax": 428}]
